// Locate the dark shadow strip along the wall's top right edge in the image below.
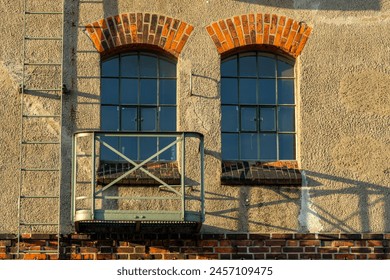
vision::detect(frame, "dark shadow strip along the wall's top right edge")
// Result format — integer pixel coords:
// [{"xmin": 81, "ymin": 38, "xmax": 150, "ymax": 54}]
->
[{"xmin": 233, "ymin": 0, "xmax": 381, "ymax": 11}]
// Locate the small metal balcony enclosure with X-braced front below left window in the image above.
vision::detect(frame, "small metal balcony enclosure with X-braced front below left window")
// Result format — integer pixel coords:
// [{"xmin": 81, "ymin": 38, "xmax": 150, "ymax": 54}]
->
[{"xmin": 72, "ymin": 131, "xmax": 204, "ymax": 231}]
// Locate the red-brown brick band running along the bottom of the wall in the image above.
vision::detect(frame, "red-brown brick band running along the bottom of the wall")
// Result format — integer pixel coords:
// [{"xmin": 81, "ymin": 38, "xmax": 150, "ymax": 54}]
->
[{"xmin": 0, "ymin": 233, "xmax": 390, "ymax": 260}]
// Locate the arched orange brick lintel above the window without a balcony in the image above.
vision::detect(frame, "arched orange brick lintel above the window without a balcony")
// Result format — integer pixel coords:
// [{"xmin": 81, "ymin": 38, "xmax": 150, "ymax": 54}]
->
[{"xmin": 206, "ymin": 13, "xmax": 312, "ymax": 57}]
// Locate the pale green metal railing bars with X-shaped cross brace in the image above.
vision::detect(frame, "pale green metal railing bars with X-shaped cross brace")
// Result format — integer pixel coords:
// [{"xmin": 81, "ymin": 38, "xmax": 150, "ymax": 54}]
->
[{"xmin": 72, "ymin": 130, "xmax": 205, "ymax": 222}]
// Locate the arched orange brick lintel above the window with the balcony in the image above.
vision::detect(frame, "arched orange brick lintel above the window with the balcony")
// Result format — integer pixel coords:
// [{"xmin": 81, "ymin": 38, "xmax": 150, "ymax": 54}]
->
[{"xmin": 85, "ymin": 13, "xmax": 194, "ymax": 57}]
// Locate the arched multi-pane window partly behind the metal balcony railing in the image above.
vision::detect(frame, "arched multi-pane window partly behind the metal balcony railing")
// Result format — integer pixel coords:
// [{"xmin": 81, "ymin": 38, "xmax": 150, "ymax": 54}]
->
[{"xmin": 100, "ymin": 51, "xmax": 176, "ymax": 161}]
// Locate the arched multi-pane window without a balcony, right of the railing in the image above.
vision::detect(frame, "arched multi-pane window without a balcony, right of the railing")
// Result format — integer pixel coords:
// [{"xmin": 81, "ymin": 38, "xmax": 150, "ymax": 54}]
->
[{"xmin": 221, "ymin": 51, "xmax": 296, "ymax": 161}]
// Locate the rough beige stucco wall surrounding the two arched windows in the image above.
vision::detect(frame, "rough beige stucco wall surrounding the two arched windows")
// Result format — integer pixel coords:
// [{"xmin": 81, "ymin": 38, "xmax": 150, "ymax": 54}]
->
[{"xmin": 0, "ymin": 0, "xmax": 390, "ymax": 232}]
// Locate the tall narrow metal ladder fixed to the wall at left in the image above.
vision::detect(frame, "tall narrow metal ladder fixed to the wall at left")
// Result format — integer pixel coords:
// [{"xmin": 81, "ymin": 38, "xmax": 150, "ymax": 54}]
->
[{"xmin": 17, "ymin": 0, "xmax": 67, "ymax": 258}]
